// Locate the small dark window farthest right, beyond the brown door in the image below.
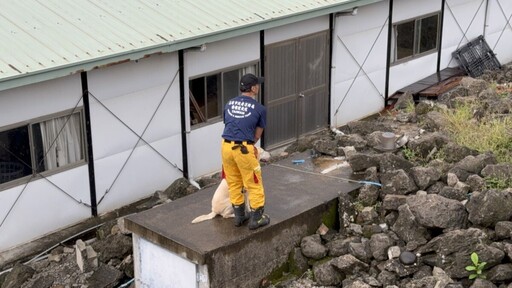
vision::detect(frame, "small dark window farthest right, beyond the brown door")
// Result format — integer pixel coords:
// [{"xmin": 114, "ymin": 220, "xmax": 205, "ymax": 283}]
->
[{"xmin": 393, "ymin": 13, "xmax": 439, "ymax": 62}]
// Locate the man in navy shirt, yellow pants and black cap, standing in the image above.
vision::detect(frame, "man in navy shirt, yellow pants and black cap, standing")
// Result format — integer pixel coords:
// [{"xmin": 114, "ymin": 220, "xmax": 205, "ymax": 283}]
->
[{"xmin": 222, "ymin": 74, "xmax": 270, "ymax": 230}]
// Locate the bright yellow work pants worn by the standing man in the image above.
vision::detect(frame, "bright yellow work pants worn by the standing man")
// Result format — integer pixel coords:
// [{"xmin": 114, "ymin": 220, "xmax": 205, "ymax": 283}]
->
[{"xmin": 222, "ymin": 140, "xmax": 265, "ymax": 209}]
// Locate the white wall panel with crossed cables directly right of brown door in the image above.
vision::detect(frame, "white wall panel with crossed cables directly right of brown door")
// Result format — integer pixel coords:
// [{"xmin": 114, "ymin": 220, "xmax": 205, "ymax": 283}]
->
[{"xmin": 331, "ymin": 2, "xmax": 388, "ymax": 127}]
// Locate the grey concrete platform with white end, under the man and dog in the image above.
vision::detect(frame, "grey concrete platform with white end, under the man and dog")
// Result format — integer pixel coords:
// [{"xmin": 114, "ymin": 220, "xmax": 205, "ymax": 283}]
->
[{"xmin": 125, "ymin": 153, "xmax": 361, "ymax": 287}]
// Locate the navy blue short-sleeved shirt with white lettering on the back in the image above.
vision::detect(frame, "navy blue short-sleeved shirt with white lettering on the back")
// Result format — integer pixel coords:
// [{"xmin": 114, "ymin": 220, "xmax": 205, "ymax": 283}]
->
[{"xmin": 222, "ymin": 95, "xmax": 267, "ymax": 141}]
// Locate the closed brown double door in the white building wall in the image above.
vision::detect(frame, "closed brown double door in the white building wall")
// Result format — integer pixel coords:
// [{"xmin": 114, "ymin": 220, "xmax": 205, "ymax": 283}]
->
[{"xmin": 265, "ymin": 31, "xmax": 329, "ymax": 148}]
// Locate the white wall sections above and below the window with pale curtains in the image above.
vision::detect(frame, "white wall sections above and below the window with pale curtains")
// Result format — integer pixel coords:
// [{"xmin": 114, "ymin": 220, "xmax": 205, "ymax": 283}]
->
[{"xmin": 0, "ymin": 75, "xmax": 91, "ymax": 251}]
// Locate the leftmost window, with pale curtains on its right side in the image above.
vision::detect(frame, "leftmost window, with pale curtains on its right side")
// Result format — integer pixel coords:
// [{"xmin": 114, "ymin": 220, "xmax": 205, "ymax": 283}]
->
[{"xmin": 0, "ymin": 111, "xmax": 85, "ymax": 184}]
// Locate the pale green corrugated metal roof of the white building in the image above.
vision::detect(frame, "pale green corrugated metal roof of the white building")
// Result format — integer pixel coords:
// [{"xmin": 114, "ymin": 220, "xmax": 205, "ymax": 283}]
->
[{"xmin": 0, "ymin": 0, "xmax": 381, "ymax": 90}]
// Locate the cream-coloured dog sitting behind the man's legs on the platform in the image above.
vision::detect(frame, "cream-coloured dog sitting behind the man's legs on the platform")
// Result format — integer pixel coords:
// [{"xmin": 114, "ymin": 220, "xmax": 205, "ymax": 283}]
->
[{"xmin": 192, "ymin": 147, "xmax": 270, "ymax": 223}]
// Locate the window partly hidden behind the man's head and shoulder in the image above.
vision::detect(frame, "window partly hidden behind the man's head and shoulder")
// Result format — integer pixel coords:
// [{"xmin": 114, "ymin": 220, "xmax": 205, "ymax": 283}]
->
[{"xmin": 189, "ymin": 63, "xmax": 258, "ymax": 125}]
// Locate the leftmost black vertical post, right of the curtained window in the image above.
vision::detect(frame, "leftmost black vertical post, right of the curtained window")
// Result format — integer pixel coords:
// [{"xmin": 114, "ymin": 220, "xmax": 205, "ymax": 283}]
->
[{"xmin": 80, "ymin": 72, "xmax": 98, "ymax": 217}]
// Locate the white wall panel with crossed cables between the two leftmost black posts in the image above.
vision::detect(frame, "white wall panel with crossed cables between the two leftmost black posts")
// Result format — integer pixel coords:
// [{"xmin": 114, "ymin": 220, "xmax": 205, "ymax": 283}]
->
[{"xmin": 88, "ymin": 53, "xmax": 183, "ymax": 213}]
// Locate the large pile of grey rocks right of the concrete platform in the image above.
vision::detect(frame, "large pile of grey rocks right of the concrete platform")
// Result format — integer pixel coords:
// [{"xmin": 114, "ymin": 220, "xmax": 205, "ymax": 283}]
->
[{"xmin": 267, "ymin": 66, "xmax": 512, "ymax": 288}]
